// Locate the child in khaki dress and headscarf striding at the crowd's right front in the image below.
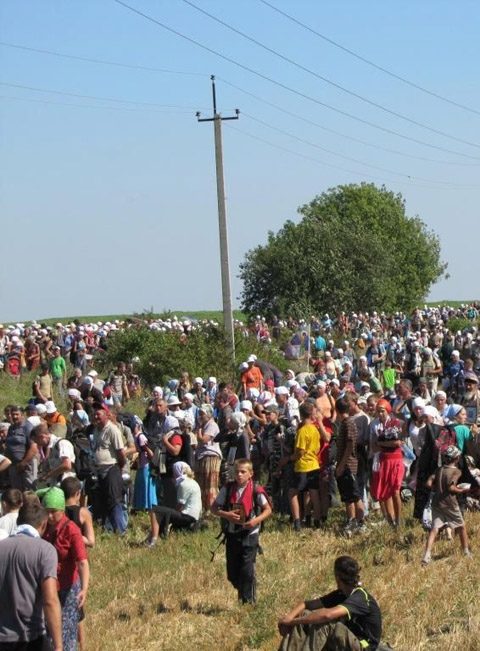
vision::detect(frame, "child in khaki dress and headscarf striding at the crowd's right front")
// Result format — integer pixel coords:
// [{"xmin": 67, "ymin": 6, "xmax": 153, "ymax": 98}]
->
[{"xmin": 422, "ymin": 445, "xmax": 471, "ymax": 566}]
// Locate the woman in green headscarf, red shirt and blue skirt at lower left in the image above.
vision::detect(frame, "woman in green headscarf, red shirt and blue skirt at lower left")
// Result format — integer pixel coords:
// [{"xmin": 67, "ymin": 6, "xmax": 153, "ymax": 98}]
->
[{"xmin": 37, "ymin": 487, "xmax": 90, "ymax": 651}]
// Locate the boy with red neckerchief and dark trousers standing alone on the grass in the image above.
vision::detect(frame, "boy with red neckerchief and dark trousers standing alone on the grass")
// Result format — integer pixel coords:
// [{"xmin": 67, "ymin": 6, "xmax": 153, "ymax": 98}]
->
[{"xmin": 212, "ymin": 459, "xmax": 272, "ymax": 604}]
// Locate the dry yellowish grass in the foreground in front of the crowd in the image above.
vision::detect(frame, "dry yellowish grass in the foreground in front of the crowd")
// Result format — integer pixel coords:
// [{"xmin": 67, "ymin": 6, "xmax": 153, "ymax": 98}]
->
[{"xmin": 86, "ymin": 510, "xmax": 480, "ymax": 651}]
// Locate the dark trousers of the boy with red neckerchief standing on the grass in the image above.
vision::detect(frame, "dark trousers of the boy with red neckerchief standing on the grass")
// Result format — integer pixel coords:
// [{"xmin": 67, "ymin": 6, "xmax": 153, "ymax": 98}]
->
[{"xmin": 226, "ymin": 533, "xmax": 258, "ymax": 604}]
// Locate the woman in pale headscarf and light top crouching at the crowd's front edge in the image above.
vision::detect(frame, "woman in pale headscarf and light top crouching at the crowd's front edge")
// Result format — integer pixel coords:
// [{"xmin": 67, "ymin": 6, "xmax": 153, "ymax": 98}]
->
[{"xmin": 150, "ymin": 461, "xmax": 202, "ymax": 547}]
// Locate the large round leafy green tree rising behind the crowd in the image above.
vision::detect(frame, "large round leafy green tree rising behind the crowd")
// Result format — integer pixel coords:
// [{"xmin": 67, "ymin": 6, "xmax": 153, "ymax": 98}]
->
[{"xmin": 240, "ymin": 183, "xmax": 447, "ymax": 316}]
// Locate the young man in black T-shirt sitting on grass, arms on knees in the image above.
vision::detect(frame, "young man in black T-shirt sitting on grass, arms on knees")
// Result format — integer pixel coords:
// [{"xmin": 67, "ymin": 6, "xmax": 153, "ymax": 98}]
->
[{"xmin": 278, "ymin": 556, "xmax": 382, "ymax": 651}]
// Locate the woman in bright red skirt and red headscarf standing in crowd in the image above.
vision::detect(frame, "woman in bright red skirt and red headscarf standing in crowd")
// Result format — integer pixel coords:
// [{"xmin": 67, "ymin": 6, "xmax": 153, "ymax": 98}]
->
[{"xmin": 370, "ymin": 398, "xmax": 405, "ymax": 527}]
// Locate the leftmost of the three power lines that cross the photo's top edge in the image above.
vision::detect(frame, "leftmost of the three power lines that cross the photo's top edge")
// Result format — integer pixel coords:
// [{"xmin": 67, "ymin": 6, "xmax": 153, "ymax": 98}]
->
[{"xmin": 113, "ymin": 0, "xmax": 480, "ymax": 160}]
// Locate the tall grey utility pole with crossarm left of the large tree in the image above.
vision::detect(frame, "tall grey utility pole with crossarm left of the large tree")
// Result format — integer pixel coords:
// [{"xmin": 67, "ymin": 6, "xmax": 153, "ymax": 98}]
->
[{"xmin": 196, "ymin": 75, "xmax": 240, "ymax": 364}]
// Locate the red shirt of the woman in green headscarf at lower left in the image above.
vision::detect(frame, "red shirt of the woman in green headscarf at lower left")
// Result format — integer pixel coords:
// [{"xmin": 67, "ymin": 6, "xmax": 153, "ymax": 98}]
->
[{"xmin": 43, "ymin": 514, "xmax": 87, "ymax": 590}]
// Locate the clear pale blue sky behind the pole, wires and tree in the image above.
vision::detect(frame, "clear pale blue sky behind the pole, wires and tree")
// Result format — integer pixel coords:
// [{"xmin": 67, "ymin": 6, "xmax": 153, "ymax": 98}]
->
[{"xmin": 0, "ymin": 0, "xmax": 480, "ymax": 321}]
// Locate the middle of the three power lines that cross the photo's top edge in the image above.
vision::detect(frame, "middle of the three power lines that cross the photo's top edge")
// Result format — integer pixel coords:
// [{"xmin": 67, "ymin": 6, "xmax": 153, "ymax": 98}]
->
[{"xmin": 182, "ymin": 0, "xmax": 480, "ymax": 149}]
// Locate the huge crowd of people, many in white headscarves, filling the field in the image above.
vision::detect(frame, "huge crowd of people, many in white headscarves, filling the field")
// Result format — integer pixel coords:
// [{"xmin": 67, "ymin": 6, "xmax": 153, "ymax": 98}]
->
[{"xmin": 0, "ymin": 305, "xmax": 480, "ymax": 649}]
